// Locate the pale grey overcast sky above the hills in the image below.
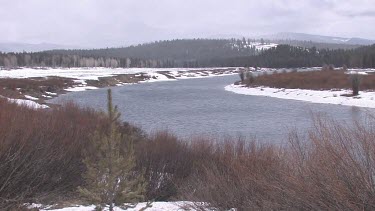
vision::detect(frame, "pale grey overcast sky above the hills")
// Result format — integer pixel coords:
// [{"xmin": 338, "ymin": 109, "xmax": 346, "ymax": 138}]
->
[{"xmin": 0, "ymin": 0, "xmax": 375, "ymax": 47}]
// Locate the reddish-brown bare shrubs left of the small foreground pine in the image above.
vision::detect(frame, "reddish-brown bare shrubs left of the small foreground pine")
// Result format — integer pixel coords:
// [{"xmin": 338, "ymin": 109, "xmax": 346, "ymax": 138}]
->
[{"xmin": 0, "ymin": 99, "xmax": 108, "ymax": 207}]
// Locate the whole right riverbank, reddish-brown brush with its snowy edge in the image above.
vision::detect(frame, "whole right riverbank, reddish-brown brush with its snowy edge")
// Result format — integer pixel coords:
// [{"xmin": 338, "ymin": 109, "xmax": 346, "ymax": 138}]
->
[{"xmin": 225, "ymin": 70, "xmax": 375, "ymax": 108}]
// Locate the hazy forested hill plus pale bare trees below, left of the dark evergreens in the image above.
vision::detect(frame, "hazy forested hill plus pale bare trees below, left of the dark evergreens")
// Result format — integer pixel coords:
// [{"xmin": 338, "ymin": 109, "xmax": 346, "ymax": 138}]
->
[{"xmin": 0, "ymin": 39, "xmax": 261, "ymax": 68}]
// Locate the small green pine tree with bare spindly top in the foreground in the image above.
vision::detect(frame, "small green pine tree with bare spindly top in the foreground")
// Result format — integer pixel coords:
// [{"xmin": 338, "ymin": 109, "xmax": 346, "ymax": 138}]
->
[{"xmin": 78, "ymin": 89, "xmax": 146, "ymax": 211}]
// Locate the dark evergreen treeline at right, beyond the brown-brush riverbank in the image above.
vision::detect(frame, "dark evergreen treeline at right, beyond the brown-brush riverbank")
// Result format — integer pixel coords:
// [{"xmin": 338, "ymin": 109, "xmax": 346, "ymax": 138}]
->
[{"xmin": 213, "ymin": 45, "xmax": 375, "ymax": 68}]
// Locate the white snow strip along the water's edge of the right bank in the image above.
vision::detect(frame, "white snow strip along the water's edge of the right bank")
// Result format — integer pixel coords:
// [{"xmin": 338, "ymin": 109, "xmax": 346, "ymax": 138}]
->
[{"xmin": 225, "ymin": 85, "xmax": 375, "ymax": 108}]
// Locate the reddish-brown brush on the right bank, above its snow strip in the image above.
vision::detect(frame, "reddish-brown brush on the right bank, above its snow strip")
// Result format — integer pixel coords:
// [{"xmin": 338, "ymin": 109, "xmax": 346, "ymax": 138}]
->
[{"xmin": 248, "ymin": 70, "xmax": 375, "ymax": 90}]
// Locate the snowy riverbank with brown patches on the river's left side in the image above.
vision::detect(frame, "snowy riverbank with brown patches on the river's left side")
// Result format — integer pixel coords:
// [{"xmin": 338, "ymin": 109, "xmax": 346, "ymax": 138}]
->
[{"xmin": 0, "ymin": 67, "xmax": 238, "ymax": 108}]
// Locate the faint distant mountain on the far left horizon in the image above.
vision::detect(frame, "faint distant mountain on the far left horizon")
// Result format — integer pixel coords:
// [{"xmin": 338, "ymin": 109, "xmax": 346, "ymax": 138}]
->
[{"xmin": 0, "ymin": 42, "xmax": 78, "ymax": 52}]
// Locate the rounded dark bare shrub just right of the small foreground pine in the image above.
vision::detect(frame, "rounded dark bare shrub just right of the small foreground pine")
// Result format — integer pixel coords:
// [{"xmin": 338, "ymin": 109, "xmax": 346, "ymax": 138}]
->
[{"xmin": 136, "ymin": 131, "xmax": 193, "ymax": 201}]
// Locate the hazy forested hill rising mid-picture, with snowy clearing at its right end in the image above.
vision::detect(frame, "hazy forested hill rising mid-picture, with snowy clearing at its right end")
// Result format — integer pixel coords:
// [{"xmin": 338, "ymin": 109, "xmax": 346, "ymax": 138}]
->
[{"xmin": 46, "ymin": 39, "xmax": 266, "ymax": 61}]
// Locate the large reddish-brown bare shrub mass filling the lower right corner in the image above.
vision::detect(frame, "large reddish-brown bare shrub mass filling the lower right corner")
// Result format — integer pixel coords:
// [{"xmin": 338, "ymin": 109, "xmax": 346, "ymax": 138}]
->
[{"xmin": 180, "ymin": 118, "xmax": 375, "ymax": 210}]
